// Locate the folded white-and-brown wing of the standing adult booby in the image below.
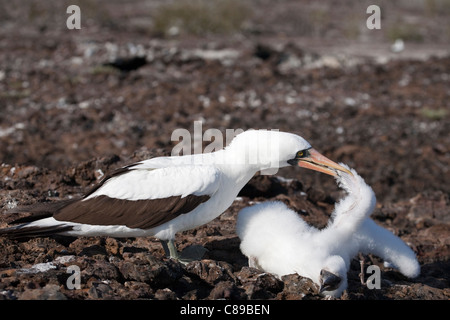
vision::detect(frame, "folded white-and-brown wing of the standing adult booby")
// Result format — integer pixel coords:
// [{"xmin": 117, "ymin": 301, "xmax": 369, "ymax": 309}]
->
[{"xmin": 53, "ymin": 165, "xmax": 221, "ymax": 229}]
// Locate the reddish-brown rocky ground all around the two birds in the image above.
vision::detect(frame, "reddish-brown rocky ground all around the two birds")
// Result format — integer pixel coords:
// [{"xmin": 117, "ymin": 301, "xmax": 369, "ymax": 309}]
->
[{"xmin": 0, "ymin": 0, "xmax": 450, "ymax": 300}]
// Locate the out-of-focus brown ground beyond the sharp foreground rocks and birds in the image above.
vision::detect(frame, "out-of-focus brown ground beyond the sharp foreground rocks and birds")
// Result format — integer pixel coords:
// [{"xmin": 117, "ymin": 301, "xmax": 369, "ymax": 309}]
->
[{"xmin": 0, "ymin": 0, "xmax": 450, "ymax": 201}]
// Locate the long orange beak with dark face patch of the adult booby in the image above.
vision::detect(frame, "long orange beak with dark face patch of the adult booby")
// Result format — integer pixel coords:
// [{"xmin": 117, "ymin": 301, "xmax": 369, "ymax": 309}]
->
[{"xmin": 289, "ymin": 148, "xmax": 353, "ymax": 176}]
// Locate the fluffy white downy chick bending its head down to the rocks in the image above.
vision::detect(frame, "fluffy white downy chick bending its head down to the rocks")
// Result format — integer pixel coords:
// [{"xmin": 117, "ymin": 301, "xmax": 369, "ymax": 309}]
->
[{"xmin": 236, "ymin": 164, "xmax": 420, "ymax": 297}]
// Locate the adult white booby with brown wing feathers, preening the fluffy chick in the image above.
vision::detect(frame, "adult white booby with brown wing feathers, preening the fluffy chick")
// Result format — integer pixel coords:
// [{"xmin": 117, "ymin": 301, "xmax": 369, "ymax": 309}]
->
[{"xmin": 0, "ymin": 130, "xmax": 347, "ymax": 260}]
